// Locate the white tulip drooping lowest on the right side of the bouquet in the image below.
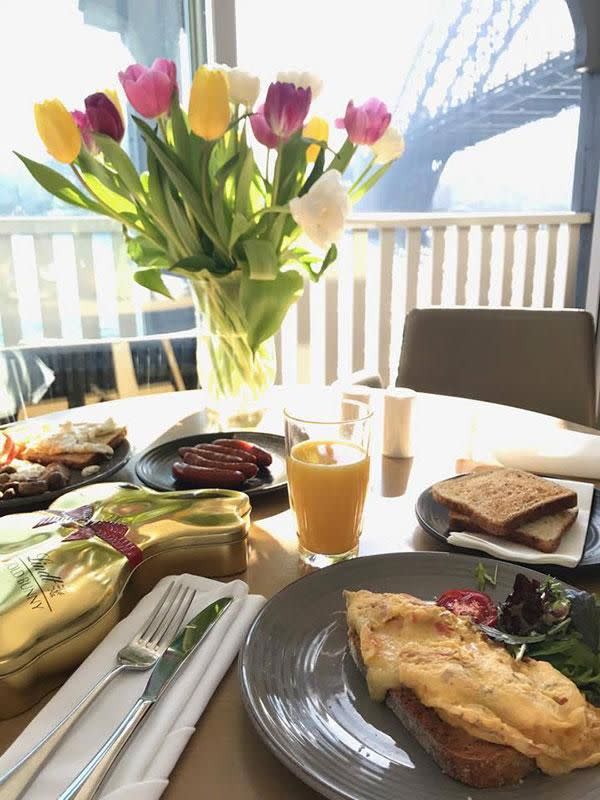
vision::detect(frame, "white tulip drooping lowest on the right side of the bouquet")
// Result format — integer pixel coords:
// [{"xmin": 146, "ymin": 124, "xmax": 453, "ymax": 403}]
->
[{"xmin": 290, "ymin": 169, "xmax": 350, "ymax": 249}]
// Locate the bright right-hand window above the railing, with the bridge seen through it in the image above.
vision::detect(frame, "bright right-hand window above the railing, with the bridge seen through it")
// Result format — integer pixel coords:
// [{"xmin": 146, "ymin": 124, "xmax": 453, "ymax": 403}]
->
[{"xmin": 237, "ymin": 0, "xmax": 580, "ymax": 211}]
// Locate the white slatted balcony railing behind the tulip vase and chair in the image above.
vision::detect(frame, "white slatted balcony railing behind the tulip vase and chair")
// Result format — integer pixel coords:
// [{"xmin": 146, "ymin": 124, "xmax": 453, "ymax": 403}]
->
[{"xmin": 0, "ymin": 212, "xmax": 591, "ymax": 390}]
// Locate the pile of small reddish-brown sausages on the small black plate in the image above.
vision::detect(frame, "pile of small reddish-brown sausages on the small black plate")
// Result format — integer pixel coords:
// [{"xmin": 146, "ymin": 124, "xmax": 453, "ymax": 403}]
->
[{"xmin": 172, "ymin": 439, "xmax": 273, "ymax": 489}]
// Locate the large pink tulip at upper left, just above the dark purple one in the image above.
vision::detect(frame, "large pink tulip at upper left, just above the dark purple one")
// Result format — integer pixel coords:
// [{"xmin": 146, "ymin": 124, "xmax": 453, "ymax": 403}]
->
[{"xmin": 119, "ymin": 58, "xmax": 177, "ymax": 119}]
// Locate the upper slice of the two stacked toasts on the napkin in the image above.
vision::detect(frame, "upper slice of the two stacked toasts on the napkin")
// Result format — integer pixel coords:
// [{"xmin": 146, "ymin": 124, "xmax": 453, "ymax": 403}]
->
[{"xmin": 432, "ymin": 468, "xmax": 577, "ymax": 536}]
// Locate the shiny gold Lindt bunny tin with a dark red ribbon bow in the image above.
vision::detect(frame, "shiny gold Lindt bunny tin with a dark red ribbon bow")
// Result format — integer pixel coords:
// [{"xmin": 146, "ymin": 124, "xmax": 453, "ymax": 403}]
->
[{"xmin": 0, "ymin": 483, "xmax": 250, "ymax": 719}]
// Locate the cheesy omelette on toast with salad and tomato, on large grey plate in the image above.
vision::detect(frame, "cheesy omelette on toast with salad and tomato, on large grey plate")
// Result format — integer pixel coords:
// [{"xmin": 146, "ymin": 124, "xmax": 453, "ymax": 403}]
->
[{"xmin": 345, "ymin": 565, "xmax": 600, "ymax": 788}]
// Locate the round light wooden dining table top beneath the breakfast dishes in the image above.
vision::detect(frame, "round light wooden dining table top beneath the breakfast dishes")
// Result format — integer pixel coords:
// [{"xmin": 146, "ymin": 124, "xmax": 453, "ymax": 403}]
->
[{"xmin": 0, "ymin": 386, "xmax": 600, "ymax": 800}]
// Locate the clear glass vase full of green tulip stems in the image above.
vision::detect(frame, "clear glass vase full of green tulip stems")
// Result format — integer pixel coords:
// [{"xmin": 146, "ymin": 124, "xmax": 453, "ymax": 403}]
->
[{"xmin": 190, "ymin": 270, "xmax": 275, "ymax": 430}]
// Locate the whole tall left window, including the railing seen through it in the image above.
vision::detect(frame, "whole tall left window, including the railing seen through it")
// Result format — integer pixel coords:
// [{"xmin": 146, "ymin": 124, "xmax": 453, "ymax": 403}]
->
[{"xmin": 0, "ymin": 0, "xmax": 196, "ymax": 419}]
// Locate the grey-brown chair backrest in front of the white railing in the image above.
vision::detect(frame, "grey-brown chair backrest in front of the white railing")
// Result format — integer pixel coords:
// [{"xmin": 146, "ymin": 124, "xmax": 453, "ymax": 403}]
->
[{"xmin": 396, "ymin": 308, "xmax": 596, "ymax": 426}]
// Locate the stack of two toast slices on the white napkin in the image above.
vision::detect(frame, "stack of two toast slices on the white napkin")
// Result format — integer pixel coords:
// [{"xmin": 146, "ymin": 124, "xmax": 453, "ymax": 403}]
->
[{"xmin": 432, "ymin": 468, "xmax": 578, "ymax": 553}]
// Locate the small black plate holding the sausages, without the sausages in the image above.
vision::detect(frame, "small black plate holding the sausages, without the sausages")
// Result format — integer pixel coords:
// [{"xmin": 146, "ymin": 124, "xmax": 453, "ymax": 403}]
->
[{"xmin": 135, "ymin": 431, "xmax": 287, "ymax": 497}]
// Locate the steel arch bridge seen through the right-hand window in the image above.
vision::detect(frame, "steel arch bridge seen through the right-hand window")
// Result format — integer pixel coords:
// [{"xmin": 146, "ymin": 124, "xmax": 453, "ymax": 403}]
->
[{"xmin": 360, "ymin": 0, "xmax": 581, "ymax": 211}]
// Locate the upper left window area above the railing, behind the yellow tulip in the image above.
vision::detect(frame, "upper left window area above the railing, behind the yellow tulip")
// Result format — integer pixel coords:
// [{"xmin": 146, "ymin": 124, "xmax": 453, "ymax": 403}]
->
[{"xmin": 0, "ymin": 0, "xmax": 190, "ymax": 216}]
